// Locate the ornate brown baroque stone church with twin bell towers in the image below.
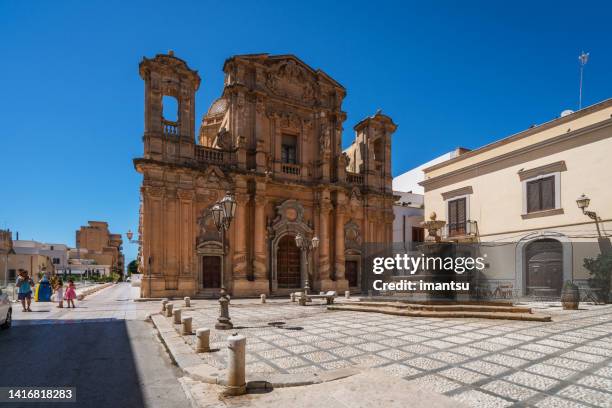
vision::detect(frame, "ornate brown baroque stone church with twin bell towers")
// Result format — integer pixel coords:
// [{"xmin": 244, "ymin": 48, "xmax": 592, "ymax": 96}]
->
[{"xmin": 134, "ymin": 51, "xmax": 397, "ymax": 297}]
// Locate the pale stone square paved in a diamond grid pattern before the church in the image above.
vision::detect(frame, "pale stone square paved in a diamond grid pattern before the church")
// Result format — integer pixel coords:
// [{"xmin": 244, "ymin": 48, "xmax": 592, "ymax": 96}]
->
[{"xmin": 175, "ymin": 300, "xmax": 612, "ymax": 408}]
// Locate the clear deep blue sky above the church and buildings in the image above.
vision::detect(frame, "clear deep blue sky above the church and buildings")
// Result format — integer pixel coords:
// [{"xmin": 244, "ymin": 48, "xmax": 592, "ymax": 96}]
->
[{"xmin": 0, "ymin": 0, "xmax": 612, "ymax": 261}]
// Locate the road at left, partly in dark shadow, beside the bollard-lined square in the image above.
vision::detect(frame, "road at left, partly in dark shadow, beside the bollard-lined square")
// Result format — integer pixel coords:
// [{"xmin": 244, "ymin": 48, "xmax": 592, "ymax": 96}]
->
[{"xmin": 0, "ymin": 284, "xmax": 190, "ymax": 408}]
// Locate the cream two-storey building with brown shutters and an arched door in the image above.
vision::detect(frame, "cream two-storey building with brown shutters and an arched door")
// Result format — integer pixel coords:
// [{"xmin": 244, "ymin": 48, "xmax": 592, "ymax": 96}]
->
[{"xmin": 421, "ymin": 99, "xmax": 612, "ymax": 294}]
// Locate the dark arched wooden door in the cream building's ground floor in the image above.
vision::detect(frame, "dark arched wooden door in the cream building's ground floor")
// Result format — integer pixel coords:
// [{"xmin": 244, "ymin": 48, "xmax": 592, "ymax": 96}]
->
[{"xmin": 525, "ymin": 239, "xmax": 563, "ymax": 296}]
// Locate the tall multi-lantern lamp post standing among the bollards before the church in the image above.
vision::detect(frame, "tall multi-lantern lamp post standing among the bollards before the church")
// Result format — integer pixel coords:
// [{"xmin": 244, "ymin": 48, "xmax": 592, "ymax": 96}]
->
[{"xmin": 211, "ymin": 191, "xmax": 236, "ymax": 330}]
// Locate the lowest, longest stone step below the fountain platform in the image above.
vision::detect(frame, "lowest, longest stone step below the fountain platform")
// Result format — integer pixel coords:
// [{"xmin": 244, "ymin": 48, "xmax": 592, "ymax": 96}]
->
[{"xmin": 327, "ymin": 304, "xmax": 551, "ymax": 322}]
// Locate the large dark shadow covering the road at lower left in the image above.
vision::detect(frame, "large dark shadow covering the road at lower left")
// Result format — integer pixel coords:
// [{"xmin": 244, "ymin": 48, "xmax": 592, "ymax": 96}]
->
[{"xmin": 0, "ymin": 319, "xmax": 145, "ymax": 407}]
